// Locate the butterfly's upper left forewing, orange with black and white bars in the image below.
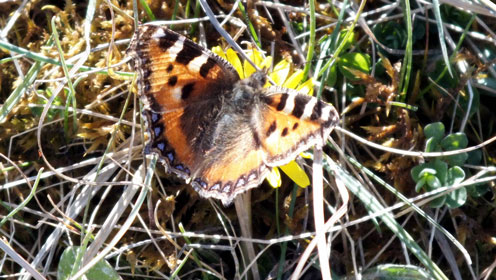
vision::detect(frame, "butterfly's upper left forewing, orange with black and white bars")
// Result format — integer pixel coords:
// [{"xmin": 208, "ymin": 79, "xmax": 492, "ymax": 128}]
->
[{"xmin": 129, "ymin": 25, "xmax": 239, "ymax": 112}]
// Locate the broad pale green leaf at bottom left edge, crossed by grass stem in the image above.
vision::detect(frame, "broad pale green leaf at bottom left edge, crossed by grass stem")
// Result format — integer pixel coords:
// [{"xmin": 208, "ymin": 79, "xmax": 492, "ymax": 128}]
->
[{"xmin": 57, "ymin": 246, "xmax": 120, "ymax": 280}]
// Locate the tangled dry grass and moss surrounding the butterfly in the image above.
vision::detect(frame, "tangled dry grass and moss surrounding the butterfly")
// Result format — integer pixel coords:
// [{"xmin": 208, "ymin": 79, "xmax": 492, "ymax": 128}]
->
[{"xmin": 0, "ymin": 0, "xmax": 496, "ymax": 279}]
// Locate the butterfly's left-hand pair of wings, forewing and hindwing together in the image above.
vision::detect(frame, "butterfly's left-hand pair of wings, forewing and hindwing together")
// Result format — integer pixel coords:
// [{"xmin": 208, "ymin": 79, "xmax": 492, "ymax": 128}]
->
[{"xmin": 128, "ymin": 25, "xmax": 239, "ymax": 179}]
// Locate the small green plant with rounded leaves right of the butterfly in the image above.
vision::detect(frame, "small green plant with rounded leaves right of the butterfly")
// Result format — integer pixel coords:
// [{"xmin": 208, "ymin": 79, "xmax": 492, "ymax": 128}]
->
[{"xmin": 411, "ymin": 122, "xmax": 468, "ymax": 208}]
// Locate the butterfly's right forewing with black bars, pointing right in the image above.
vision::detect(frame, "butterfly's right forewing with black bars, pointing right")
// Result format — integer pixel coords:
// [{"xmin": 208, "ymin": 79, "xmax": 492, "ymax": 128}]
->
[{"xmin": 260, "ymin": 87, "xmax": 338, "ymax": 166}]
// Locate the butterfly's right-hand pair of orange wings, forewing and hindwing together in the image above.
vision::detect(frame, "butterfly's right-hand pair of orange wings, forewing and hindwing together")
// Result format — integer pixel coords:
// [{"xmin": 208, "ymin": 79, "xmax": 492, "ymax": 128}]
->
[{"xmin": 188, "ymin": 86, "xmax": 339, "ymax": 205}]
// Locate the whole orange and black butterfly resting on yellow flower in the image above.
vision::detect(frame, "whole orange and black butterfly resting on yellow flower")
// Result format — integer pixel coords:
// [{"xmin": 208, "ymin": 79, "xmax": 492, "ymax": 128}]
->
[{"xmin": 128, "ymin": 25, "xmax": 339, "ymax": 205}]
